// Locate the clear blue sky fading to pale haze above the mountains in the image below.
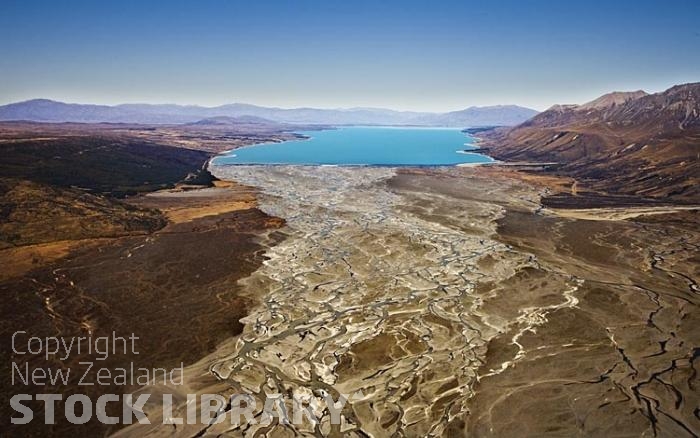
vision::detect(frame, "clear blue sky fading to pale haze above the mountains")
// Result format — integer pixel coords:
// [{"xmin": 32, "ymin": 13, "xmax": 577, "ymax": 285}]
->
[{"xmin": 0, "ymin": 0, "xmax": 700, "ymax": 112}]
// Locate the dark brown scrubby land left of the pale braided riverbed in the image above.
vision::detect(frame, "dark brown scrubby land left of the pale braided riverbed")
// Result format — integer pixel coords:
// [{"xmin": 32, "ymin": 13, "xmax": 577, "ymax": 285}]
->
[{"xmin": 0, "ymin": 123, "xmax": 291, "ymax": 436}]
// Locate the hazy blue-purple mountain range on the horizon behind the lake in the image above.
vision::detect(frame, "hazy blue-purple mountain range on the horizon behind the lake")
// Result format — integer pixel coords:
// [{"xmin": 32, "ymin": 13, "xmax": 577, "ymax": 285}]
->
[{"xmin": 0, "ymin": 99, "xmax": 537, "ymax": 127}]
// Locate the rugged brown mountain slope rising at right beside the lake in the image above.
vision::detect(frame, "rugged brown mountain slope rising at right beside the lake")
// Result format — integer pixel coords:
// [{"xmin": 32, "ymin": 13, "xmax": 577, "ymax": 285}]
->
[{"xmin": 479, "ymin": 83, "xmax": 700, "ymax": 203}]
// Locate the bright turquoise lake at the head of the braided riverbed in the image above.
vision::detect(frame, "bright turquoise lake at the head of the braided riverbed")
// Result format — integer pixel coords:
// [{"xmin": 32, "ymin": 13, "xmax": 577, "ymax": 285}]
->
[{"xmin": 213, "ymin": 127, "xmax": 493, "ymax": 166}]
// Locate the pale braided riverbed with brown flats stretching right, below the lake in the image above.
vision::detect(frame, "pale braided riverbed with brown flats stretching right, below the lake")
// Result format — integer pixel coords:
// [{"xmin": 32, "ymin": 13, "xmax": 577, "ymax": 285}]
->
[{"xmin": 126, "ymin": 166, "xmax": 700, "ymax": 437}]
